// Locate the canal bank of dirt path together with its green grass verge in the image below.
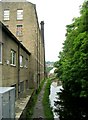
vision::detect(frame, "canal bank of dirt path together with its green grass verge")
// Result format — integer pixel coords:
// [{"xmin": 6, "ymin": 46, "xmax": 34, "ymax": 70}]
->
[{"xmin": 31, "ymin": 79, "xmax": 54, "ymax": 120}]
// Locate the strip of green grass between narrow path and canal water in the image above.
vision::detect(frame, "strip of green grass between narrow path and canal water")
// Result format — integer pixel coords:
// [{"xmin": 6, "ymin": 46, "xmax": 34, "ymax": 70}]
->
[{"xmin": 42, "ymin": 79, "xmax": 54, "ymax": 120}]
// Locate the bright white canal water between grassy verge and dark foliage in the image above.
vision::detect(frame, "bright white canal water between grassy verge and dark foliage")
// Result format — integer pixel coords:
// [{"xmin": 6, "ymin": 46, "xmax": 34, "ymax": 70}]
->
[{"xmin": 49, "ymin": 81, "xmax": 62, "ymax": 120}]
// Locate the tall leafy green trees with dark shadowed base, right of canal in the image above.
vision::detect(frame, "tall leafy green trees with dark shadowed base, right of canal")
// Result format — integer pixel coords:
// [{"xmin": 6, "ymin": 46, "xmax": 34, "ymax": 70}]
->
[{"xmin": 55, "ymin": 1, "xmax": 88, "ymax": 120}]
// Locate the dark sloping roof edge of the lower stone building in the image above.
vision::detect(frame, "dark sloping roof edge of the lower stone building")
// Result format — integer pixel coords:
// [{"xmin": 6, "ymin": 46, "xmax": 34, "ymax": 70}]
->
[{"xmin": 0, "ymin": 21, "xmax": 31, "ymax": 55}]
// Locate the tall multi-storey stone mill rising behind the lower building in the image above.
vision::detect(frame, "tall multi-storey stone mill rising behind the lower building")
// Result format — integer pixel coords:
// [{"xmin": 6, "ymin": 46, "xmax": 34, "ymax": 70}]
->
[{"xmin": 0, "ymin": 0, "xmax": 45, "ymax": 89}]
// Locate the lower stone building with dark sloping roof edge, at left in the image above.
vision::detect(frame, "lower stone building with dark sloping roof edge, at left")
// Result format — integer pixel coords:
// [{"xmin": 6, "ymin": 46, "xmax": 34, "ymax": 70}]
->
[{"xmin": 0, "ymin": 22, "xmax": 31, "ymax": 98}]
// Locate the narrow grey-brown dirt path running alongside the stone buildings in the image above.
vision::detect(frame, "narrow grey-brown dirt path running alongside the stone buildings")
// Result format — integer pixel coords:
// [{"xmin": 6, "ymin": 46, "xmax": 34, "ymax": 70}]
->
[{"xmin": 32, "ymin": 82, "xmax": 46, "ymax": 119}]
